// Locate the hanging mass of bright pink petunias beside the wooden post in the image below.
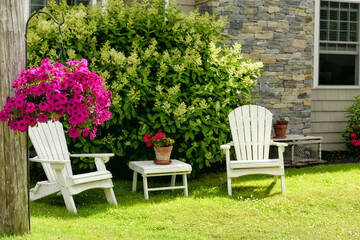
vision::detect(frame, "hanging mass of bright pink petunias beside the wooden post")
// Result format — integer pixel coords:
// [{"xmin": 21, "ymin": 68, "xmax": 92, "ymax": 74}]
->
[{"xmin": 0, "ymin": 59, "xmax": 111, "ymax": 139}]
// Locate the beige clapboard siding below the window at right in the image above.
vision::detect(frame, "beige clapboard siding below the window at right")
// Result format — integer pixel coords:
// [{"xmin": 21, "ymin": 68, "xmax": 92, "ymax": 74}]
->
[{"xmin": 311, "ymin": 89, "xmax": 360, "ymax": 151}]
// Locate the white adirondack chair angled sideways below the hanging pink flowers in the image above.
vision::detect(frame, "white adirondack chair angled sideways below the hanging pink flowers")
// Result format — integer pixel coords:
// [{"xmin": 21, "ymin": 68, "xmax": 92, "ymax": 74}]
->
[{"xmin": 29, "ymin": 122, "xmax": 117, "ymax": 213}]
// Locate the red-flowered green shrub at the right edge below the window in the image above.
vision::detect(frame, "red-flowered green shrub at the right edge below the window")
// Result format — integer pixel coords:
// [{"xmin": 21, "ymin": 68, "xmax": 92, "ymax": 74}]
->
[{"xmin": 342, "ymin": 96, "xmax": 360, "ymax": 153}]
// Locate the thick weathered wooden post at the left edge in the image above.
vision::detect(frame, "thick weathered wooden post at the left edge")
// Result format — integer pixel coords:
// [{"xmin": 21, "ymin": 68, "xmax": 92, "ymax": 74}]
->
[{"xmin": 0, "ymin": 0, "xmax": 30, "ymax": 234}]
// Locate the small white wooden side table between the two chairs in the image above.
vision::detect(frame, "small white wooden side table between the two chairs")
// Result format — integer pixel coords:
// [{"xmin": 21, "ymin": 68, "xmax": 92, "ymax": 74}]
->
[{"xmin": 129, "ymin": 159, "xmax": 192, "ymax": 200}]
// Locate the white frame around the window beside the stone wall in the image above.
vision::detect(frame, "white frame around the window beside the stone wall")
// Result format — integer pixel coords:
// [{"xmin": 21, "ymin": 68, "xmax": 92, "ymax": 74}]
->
[{"xmin": 313, "ymin": 0, "xmax": 360, "ymax": 89}]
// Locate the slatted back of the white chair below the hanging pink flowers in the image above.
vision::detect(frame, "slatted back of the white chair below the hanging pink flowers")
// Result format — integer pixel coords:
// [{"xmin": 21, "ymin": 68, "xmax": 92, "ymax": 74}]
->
[{"xmin": 29, "ymin": 121, "xmax": 72, "ymax": 181}]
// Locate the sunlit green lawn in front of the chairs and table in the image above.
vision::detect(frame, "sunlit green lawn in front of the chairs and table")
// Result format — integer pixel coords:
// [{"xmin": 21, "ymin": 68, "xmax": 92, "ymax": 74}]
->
[{"xmin": 0, "ymin": 164, "xmax": 360, "ymax": 240}]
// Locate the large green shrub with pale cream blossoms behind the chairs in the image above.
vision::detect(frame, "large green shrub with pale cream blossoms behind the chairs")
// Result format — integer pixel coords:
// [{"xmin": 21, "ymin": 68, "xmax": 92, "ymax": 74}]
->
[{"xmin": 28, "ymin": 0, "xmax": 262, "ymax": 172}]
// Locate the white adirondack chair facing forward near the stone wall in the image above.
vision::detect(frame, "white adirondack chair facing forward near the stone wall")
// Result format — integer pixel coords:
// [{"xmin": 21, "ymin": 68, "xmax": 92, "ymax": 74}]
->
[{"xmin": 220, "ymin": 105, "xmax": 287, "ymax": 196}]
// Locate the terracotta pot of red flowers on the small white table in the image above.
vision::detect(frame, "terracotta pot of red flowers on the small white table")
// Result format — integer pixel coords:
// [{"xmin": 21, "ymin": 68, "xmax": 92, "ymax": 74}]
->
[{"xmin": 143, "ymin": 129, "xmax": 175, "ymax": 165}]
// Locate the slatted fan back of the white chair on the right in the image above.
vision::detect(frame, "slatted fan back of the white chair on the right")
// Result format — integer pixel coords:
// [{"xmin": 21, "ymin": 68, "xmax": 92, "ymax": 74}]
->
[{"xmin": 229, "ymin": 105, "xmax": 272, "ymax": 160}]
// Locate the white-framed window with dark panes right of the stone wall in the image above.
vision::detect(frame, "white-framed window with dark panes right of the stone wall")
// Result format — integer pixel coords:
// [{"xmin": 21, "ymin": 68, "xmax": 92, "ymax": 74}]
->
[{"xmin": 314, "ymin": 0, "xmax": 360, "ymax": 87}]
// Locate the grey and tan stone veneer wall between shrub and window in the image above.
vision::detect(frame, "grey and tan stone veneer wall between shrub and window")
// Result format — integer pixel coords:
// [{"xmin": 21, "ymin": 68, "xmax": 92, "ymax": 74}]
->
[{"xmin": 195, "ymin": 0, "xmax": 314, "ymax": 134}]
